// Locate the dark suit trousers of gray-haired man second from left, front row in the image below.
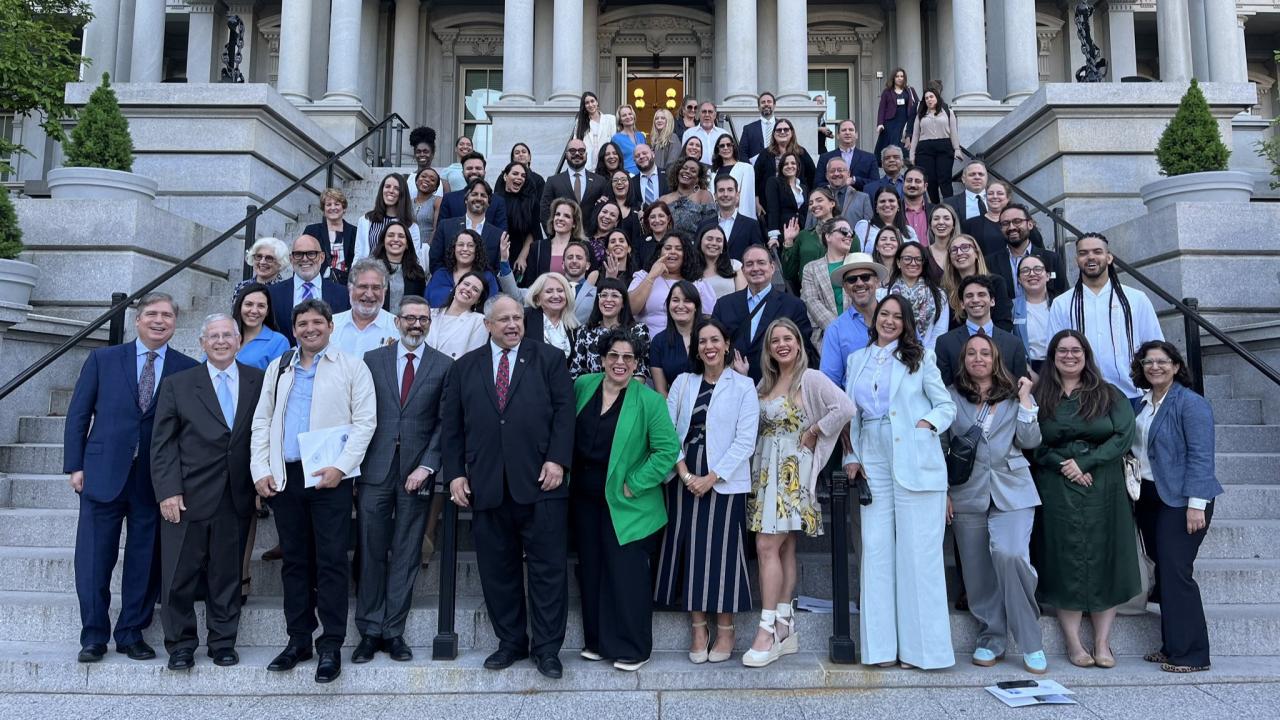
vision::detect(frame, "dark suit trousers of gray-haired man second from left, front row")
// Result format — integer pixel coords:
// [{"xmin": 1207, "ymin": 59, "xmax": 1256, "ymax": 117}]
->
[{"xmin": 160, "ymin": 486, "xmax": 248, "ymax": 655}]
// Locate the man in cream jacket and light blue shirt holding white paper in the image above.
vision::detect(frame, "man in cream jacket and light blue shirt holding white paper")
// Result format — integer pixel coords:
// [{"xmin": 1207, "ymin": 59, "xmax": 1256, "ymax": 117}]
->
[{"xmin": 250, "ymin": 300, "xmax": 378, "ymax": 683}]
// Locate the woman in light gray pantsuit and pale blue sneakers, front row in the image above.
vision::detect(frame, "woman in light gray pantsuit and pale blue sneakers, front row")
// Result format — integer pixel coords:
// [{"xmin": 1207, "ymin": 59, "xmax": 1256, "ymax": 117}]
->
[{"xmin": 947, "ymin": 334, "xmax": 1048, "ymax": 675}]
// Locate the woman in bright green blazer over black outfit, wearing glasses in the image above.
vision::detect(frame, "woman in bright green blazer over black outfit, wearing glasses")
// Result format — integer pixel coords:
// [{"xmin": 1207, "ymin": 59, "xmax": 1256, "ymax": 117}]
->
[{"xmin": 570, "ymin": 328, "xmax": 680, "ymax": 671}]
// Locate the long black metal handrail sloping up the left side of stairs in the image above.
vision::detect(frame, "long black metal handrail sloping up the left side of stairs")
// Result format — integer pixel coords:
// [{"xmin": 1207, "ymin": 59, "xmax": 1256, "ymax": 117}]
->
[{"xmin": 0, "ymin": 113, "xmax": 408, "ymax": 400}]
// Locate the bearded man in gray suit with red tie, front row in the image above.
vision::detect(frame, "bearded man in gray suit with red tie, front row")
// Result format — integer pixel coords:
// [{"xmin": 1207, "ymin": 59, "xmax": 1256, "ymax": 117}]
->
[{"xmin": 351, "ymin": 295, "xmax": 453, "ymax": 662}]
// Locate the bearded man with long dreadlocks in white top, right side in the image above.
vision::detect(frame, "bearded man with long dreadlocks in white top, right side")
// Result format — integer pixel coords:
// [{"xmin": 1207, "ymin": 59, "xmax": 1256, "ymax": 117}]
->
[{"xmin": 1048, "ymin": 233, "xmax": 1165, "ymax": 405}]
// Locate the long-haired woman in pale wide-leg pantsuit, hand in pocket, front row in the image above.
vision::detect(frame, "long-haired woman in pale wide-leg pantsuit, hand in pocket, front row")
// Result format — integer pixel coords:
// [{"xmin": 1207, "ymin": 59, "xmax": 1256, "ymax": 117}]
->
[{"xmin": 844, "ymin": 289, "xmax": 956, "ymax": 670}]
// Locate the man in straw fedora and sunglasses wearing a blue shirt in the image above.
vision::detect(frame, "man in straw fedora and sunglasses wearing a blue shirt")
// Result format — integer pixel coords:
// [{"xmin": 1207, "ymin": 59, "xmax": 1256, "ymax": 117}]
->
[{"xmin": 819, "ymin": 252, "xmax": 888, "ymax": 387}]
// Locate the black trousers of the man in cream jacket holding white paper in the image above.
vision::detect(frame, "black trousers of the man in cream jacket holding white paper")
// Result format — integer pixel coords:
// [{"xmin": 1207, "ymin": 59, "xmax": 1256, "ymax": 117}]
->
[{"xmin": 271, "ymin": 462, "xmax": 352, "ymax": 651}]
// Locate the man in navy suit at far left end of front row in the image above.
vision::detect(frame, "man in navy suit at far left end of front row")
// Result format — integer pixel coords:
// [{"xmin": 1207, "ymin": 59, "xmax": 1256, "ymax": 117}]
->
[{"xmin": 63, "ymin": 292, "xmax": 197, "ymax": 662}]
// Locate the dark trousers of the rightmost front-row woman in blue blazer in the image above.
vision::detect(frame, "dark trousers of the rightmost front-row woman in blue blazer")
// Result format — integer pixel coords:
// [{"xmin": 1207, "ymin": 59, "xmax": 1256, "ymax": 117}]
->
[{"xmin": 1137, "ymin": 480, "xmax": 1213, "ymax": 666}]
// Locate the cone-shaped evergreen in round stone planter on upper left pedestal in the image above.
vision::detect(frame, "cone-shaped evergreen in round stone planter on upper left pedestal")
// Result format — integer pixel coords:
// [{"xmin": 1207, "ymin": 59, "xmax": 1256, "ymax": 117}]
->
[{"xmin": 49, "ymin": 73, "xmax": 160, "ymax": 202}]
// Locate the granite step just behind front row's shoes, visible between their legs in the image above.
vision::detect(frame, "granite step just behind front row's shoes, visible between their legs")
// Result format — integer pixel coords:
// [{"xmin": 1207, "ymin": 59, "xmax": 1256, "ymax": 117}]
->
[{"xmin": 0, "ymin": 592, "xmax": 1280, "ymax": 657}]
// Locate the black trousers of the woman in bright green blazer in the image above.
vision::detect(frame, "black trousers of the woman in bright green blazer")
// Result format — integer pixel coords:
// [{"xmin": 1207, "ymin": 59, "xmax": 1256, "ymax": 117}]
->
[{"xmin": 570, "ymin": 496, "xmax": 662, "ymax": 661}]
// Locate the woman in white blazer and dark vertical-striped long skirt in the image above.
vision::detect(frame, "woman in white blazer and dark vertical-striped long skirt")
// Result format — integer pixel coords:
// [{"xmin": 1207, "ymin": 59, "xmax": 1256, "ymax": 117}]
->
[{"xmin": 654, "ymin": 318, "xmax": 760, "ymax": 664}]
